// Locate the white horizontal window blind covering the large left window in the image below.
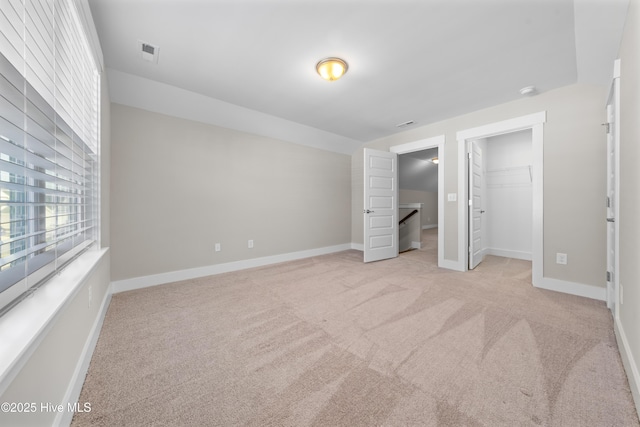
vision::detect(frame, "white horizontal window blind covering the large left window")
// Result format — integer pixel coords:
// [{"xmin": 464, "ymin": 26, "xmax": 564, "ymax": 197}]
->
[{"xmin": 0, "ymin": 0, "xmax": 99, "ymax": 310}]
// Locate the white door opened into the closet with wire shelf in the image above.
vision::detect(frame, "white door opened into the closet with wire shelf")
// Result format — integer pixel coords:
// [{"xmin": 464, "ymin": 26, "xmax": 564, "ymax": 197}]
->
[{"xmin": 469, "ymin": 142, "xmax": 484, "ymax": 270}]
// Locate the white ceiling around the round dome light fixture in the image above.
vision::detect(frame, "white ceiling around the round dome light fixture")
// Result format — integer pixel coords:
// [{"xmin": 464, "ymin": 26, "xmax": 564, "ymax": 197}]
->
[{"xmin": 89, "ymin": 0, "xmax": 628, "ymax": 143}]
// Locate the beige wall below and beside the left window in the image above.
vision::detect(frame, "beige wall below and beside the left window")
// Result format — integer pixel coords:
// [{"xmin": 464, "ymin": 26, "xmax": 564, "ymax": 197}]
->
[{"xmin": 0, "ymin": 73, "xmax": 111, "ymax": 426}]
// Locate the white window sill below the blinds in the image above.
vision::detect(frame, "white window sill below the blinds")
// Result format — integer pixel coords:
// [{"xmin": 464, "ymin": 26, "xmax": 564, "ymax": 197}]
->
[{"xmin": 0, "ymin": 248, "xmax": 109, "ymax": 395}]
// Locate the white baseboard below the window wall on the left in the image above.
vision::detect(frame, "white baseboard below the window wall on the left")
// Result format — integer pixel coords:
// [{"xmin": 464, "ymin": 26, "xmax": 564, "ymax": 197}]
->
[{"xmin": 53, "ymin": 286, "xmax": 111, "ymax": 426}]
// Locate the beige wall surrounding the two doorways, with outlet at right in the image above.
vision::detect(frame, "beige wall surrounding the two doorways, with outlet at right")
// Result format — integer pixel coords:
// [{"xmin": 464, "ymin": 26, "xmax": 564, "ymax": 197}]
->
[{"xmin": 351, "ymin": 84, "xmax": 607, "ymax": 287}]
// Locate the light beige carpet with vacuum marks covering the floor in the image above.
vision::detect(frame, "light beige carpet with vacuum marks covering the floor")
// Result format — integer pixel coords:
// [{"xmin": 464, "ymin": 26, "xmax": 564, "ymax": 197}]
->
[{"xmin": 72, "ymin": 230, "xmax": 639, "ymax": 426}]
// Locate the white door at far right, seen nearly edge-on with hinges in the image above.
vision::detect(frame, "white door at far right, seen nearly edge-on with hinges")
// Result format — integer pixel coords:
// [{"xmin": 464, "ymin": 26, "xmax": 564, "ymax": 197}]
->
[{"xmin": 605, "ymin": 67, "xmax": 620, "ymax": 316}]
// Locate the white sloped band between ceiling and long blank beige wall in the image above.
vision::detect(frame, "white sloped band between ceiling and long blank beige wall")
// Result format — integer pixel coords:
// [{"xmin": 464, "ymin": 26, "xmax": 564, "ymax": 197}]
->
[{"xmin": 107, "ymin": 67, "xmax": 362, "ymax": 155}]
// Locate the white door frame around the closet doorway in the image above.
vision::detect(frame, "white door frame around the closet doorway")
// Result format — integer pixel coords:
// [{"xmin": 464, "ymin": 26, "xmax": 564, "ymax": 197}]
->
[{"xmin": 456, "ymin": 111, "xmax": 547, "ymax": 286}]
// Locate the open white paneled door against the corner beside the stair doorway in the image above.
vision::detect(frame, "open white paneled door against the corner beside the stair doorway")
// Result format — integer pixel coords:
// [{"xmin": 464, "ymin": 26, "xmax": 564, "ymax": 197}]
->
[{"xmin": 363, "ymin": 148, "xmax": 398, "ymax": 262}]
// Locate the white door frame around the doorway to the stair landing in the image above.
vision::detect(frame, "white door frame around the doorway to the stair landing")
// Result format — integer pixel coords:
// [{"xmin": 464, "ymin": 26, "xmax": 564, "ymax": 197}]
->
[{"xmin": 389, "ymin": 135, "xmax": 454, "ymax": 269}]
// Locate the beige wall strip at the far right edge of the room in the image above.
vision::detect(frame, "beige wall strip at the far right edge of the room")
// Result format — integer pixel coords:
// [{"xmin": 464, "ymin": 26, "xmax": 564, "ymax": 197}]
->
[{"xmin": 618, "ymin": 0, "xmax": 640, "ymax": 408}]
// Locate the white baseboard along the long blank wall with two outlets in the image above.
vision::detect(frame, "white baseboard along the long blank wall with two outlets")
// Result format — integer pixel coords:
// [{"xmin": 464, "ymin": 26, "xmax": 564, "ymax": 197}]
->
[{"xmin": 111, "ymin": 243, "xmax": 352, "ymax": 294}]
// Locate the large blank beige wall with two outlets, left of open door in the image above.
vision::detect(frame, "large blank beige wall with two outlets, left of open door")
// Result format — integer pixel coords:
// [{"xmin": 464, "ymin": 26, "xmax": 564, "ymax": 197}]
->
[{"xmin": 111, "ymin": 104, "xmax": 351, "ymax": 281}]
